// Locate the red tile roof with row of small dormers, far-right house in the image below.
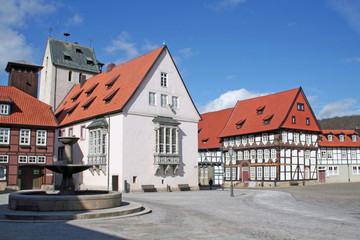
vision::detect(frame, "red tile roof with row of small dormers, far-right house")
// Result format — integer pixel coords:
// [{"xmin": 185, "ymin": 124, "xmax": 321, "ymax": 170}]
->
[{"xmin": 319, "ymin": 130, "xmax": 360, "ymax": 147}]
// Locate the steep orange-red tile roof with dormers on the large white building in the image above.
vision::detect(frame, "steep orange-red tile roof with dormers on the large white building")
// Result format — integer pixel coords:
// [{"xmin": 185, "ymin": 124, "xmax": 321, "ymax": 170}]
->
[{"xmin": 55, "ymin": 46, "xmax": 167, "ymax": 125}]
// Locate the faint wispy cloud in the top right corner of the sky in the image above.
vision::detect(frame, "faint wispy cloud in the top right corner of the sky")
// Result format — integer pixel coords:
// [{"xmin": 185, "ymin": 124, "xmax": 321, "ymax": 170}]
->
[{"xmin": 330, "ymin": 0, "xmax": 360, "ymax": 34}]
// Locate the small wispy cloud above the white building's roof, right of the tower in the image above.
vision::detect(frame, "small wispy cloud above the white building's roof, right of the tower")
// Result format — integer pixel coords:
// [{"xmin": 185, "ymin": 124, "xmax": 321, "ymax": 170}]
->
[{"xmin": 106, "ymin": 31, "xmax": 139, "ymax": 65}]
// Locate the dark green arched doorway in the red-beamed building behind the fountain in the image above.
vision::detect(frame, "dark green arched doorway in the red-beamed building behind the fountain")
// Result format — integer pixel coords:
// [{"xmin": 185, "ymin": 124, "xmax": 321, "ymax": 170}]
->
[{"xmin": 18, "ymin": 166, "xmax": 44, "ymax": 190}]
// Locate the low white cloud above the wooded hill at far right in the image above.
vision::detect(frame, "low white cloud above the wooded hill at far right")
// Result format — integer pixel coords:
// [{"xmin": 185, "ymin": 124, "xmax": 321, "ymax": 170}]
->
[{"xmin": 319, "ymin": 98, "xmax": 360, "ymax": 119}]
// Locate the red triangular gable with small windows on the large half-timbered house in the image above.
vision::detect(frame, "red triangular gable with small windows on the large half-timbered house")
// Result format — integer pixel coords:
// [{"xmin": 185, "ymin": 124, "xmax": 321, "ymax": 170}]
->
[{"xmin": 281, "ymin": 90, "xmax": 320, "ymax": 131}]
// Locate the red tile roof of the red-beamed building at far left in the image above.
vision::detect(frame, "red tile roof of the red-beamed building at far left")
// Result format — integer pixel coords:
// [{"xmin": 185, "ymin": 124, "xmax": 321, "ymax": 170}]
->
[{"xmin": 0, "ymin": 86, "xmax": 57, "ymax": 127}]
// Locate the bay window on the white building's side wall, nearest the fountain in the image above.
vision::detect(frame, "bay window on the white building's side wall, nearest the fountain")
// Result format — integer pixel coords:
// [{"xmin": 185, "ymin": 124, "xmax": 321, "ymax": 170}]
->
[{"xmin": 88, "ymin": 128, "xmax": 107, "ymax": 164}]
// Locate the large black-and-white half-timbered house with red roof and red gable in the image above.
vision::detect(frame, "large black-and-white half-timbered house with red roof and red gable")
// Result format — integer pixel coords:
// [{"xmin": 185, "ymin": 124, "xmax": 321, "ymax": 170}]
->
[{"xmin": 219, "ymin": 88, "xmax": 321, "ymax": 186}]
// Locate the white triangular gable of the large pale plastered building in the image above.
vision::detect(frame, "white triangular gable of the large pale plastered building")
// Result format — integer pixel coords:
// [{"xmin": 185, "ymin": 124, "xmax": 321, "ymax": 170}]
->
[{"xmin": 123, "ymin": 48, "xmax": 200, "ymax": 122}]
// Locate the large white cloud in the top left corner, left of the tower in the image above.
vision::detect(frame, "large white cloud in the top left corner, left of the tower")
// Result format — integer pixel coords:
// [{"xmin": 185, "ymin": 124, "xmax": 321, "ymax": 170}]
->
[{"xmin": 0, "ymin": 0, "xmax": 55, "ymax": 78}]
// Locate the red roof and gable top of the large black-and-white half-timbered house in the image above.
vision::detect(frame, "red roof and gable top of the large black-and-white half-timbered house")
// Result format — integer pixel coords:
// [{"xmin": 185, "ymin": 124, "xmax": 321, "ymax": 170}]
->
[{"xmin": 219, "ymin": 88, "xmax": 320, "ymax": 137}]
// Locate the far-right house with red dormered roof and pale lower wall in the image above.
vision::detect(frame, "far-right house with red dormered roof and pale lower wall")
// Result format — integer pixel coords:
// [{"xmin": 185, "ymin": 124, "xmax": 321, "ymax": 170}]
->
[{"xmin": 317, "ymin": 130, "xmax": 360, "ymax": 183}]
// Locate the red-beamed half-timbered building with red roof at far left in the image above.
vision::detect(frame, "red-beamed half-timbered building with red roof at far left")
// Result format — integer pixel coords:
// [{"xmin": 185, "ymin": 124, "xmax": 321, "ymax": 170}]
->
[{"xmin": 0, "ymin": 86, "xmax": 57, "ymax": 189}]
